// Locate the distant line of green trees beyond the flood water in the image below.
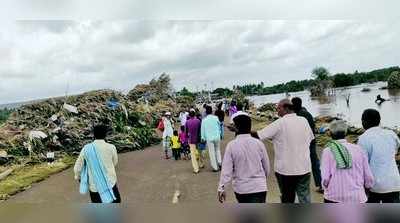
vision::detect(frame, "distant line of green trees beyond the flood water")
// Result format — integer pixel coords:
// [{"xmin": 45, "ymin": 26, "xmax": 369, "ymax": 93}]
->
[{"xmin": 178, "ymin": 66, "xmax": 400, "ymax": 97}]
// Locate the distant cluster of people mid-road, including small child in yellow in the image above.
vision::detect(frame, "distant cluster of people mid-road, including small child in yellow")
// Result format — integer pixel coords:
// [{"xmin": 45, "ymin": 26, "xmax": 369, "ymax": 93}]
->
[{"xmin": 159, "ymin": 104, "xmax": 225, "ymax": 174}]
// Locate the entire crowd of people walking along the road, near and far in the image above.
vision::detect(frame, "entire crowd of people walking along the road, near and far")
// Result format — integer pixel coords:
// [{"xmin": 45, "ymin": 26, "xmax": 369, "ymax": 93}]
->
[{"xmin": 74, "ymin": 98, "xmax": 400, "ymax": 203}]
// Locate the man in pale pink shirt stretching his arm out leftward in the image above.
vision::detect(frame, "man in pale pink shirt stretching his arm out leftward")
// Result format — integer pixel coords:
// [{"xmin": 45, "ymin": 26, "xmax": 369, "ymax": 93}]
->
[{"xmin": 253, "ymin": 99, "xmax": 314, "ymax": 203}]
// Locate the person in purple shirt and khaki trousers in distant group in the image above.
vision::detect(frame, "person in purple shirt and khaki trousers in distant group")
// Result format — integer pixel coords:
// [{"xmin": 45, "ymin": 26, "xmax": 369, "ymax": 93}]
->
[{"xmin": 186, "ymin": 110, "xmax": 203, "ymax": 174}]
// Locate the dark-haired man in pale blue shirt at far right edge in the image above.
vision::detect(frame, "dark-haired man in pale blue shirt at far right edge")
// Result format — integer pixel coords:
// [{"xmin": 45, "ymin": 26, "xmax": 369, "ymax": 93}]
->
[{"xmin": 358, "ymin": 109, "xmax": 400, "ymax": 203}]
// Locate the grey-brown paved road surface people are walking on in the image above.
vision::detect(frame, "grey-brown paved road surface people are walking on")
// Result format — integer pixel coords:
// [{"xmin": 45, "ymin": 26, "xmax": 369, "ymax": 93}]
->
[{"xmin": 7, "ymin": 128, "xmax": 322, "ymax": 204}]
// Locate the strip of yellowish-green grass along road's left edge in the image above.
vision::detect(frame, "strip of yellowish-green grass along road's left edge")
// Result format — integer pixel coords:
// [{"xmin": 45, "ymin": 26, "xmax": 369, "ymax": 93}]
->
[{"xmin": 0, "ymin": 156, "xmax": 75, "ymax": 200}]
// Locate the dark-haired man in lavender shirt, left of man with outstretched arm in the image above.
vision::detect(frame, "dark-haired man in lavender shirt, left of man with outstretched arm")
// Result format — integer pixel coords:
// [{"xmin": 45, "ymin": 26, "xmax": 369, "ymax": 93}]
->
[{"xmin": 218, "ymin": 113, "xmax": 270, "ymax": 203}]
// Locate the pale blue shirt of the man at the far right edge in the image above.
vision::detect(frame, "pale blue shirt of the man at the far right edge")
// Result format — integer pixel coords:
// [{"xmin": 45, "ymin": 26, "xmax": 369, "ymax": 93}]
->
[{"xmin": 358, "ymin": 127, "xmax": 400, "ymax": 193}]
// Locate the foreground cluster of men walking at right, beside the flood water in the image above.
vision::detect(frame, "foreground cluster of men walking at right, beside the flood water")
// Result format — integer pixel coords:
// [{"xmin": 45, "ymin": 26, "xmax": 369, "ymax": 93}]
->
[{"xmin": 218, "ymin": 98, "xmax": 400, "ymax": 203}]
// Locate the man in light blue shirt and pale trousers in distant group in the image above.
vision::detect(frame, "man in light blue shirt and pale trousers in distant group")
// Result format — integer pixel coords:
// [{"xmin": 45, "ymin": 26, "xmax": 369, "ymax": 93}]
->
[{"xmin": 201, "ymin": 106, "xmax": 222, "ymax": 172}]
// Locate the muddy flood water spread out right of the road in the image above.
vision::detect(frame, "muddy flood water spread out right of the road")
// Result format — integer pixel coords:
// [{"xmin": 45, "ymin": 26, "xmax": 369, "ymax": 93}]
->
[{"xmin": 250, "ymin": 82, "xmax": 400, "ymax": 128}]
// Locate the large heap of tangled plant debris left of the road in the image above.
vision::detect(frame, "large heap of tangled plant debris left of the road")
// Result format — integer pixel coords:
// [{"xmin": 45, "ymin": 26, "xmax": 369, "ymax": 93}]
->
[{"xmin": 0, "ymin": 90, "xmax": 158, "ymax": 162}]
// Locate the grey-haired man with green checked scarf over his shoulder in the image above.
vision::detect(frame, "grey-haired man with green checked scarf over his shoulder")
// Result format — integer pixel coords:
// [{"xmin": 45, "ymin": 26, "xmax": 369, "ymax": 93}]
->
[{"xmin": 321, "ymin": 120, "xmax": 374, "ymax": 203}]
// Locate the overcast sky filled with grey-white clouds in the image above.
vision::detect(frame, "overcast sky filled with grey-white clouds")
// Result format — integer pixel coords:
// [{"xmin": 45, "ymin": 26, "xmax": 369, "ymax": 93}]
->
[{"xmin": 0, "ymin": 20, "xmax": 400, "ymax": 104}]
